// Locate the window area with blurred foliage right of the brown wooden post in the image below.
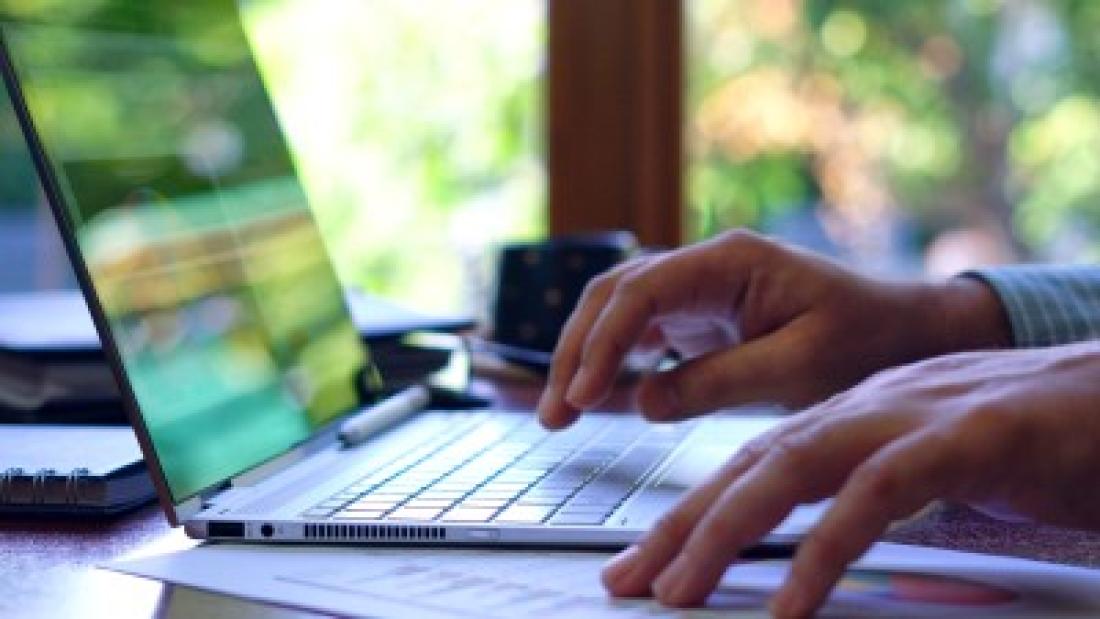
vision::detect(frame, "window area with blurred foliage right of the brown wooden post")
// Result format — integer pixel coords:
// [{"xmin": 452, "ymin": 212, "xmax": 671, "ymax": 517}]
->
[{"xmin": 685, "ymin": 0, "xmax": 1100, "ymax": 273}]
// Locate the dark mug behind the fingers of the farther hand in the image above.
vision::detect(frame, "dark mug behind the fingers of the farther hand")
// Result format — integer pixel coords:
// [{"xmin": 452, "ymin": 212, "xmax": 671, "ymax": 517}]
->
[{"xmin": 493, "ymin": 232, "xmax": 638, "ymax": 369}]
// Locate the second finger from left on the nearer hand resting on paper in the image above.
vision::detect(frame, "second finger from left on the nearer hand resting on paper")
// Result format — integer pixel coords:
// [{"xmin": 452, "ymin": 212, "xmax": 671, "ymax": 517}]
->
[{"xmin": 653, "ymin": 410, "xmax": 899, "ymax": 607}]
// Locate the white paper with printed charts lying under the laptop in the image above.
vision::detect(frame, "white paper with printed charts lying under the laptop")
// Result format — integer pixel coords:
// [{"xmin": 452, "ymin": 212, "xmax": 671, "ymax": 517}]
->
[{"xmin": 110, "ymin": 544, "xmax": 1100, "ymax": 618}]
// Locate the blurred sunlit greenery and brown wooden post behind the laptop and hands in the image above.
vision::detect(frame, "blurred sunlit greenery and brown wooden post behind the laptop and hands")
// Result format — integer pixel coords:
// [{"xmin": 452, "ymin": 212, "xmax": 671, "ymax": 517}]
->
[{"xmin": 0, "ymin": 0, "xmax": 1100, "ymax": 313}]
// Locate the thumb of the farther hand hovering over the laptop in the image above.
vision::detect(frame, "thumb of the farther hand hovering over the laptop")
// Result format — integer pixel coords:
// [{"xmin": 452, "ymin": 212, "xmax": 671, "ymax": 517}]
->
[{"xmin": 638, "ymin": 323, "xmax": 809, "ymax": 422}]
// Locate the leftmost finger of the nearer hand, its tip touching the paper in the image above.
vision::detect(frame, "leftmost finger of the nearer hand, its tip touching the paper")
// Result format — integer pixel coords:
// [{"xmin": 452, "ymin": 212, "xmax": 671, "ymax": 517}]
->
[{"xmin": 603, "ymin": 414, "xmax": 818, "ymax": 597}]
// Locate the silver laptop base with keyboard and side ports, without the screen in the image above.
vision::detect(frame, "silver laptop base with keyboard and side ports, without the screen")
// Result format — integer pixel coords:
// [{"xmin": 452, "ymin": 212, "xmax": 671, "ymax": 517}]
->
[{"xmin": 186, "ymin": 411, "xmax": 817, "ymax": 546}]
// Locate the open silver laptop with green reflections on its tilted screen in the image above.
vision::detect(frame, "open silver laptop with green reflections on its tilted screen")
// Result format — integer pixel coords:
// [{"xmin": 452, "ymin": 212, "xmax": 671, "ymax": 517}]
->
[{"xmin": 0, "ymin": 0, "xmax": 817, "ymax": 548}]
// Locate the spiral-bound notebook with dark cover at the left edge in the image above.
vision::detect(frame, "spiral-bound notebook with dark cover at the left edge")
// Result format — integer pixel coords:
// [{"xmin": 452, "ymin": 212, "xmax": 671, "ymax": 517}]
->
[{"xmin": 0, "ymin": 425, "xmax": 155, "ymax": 516}]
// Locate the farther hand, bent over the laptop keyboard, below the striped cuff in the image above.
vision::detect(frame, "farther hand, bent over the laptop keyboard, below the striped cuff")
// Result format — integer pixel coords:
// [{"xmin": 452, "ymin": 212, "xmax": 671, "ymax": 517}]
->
[{"xmin": 538, "ymin": 231, "xmax": 1010, "ymax": 429}]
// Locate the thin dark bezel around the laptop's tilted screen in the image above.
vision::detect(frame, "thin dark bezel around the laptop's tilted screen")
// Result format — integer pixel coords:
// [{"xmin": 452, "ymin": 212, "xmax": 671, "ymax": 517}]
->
[{"xmin": 0, "ymin": 16, "xmax": 374, "ymax": 527}]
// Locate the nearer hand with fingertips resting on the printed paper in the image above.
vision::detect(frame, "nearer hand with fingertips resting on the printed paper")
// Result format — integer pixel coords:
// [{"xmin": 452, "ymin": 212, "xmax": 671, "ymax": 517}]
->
[{"xmin": 604, "ymin": 342, "xmax": 1100, "ymax": 617}]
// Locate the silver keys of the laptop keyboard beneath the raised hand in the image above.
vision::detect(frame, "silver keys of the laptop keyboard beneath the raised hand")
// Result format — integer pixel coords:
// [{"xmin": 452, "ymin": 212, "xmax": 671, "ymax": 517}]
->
[{"xmin": 303, "ymin": 417, "xmax": 690, "ymax": 524}]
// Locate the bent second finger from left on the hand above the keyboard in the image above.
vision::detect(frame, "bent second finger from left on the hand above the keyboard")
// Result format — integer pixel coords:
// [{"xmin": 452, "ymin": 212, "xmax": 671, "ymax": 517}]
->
[{"xmin": 565, "ymin": 244, "xmax": 748, "ymax": 409}]
